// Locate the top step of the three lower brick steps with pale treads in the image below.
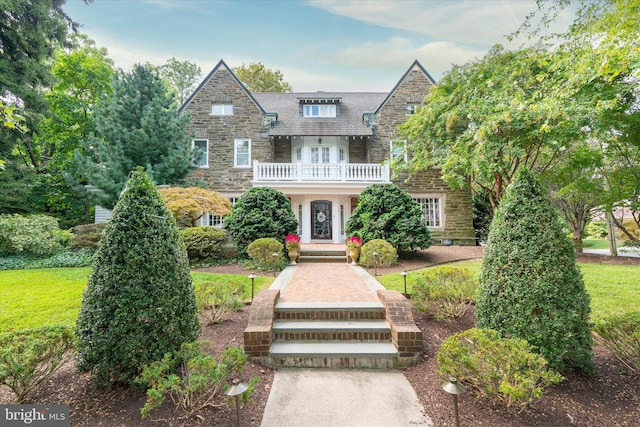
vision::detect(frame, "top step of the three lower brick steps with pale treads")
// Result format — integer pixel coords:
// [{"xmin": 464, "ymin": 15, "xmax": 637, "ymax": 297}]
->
[{"xmin": 275, "ymin": 302, "xmax": 386, "ymax": 320}]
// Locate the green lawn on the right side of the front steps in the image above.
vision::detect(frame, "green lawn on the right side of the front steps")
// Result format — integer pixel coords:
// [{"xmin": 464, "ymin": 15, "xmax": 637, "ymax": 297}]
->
[{"xmin": 377, "ymin": 260, "xmax": 640, "ymax": 322}]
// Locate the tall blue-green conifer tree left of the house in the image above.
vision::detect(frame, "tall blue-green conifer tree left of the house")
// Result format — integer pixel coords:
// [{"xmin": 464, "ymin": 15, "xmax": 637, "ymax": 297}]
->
[{"xmin": 74, "ymin": 65, "xmax": 193, "ymax": 209}]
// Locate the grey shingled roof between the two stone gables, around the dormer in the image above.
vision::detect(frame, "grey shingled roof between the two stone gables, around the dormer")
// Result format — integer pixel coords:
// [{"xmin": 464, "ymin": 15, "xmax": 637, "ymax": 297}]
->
[{"xmin": 254, "ymin": 92, "xmax": 386, "ymax": 136}]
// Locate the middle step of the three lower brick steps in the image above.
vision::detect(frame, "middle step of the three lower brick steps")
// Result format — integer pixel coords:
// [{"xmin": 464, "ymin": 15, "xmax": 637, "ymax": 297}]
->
[{"xmin": 273, "ymin": 320, "xmax": 391, "ymax": 342}]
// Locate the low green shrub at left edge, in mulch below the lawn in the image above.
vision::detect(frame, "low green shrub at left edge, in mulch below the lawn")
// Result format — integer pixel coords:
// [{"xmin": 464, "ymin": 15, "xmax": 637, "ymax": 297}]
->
[{"xmin": 0, "ymin": 325, "xmax": 74, "ymax": 403}]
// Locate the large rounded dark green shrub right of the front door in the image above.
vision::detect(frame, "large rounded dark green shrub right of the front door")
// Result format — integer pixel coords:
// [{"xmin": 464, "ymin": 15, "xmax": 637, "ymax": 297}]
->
[{"xmin": 345, "ymin": 184, "xmax": 431, "ymax": 253}]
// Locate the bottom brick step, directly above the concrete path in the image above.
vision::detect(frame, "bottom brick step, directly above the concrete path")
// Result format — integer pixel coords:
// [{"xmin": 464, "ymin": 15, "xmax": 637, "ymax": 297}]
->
[{"xmin": 268, "ymin": 342, "xmax": 398, "ymax": 369}]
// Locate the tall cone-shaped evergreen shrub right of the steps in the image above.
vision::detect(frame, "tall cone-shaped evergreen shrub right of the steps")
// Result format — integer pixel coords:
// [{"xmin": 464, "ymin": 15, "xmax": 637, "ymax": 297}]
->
[{"xmin": 475, "ymin": 168, "xmax": 594, "ymax": 374}]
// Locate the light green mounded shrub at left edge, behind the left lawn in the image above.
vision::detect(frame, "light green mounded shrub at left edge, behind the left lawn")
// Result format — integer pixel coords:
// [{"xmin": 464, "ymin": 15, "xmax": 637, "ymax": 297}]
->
[{"xmin": 0, "ymin": 214, "xmax": 71, "ymax": 255}]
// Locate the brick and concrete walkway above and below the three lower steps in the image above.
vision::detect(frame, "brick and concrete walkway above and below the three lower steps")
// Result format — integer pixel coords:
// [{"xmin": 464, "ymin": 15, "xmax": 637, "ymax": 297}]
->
[{"xmin": 261, "ymin": 263, "xmax": 433, "ymax": 427}]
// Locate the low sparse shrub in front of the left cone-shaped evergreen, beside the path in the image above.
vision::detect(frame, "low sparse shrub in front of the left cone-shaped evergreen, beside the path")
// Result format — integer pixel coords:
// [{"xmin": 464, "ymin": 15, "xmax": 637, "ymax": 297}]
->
[{"xmin": 136, "ymin": 341, "xmax": 259, "ymax": 419}]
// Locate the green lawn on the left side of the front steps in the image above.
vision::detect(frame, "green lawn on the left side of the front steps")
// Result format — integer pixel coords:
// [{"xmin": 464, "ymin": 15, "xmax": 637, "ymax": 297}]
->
[{"xmin": 0, "ymin": 267, "xmax": 273, "ymax": 332}]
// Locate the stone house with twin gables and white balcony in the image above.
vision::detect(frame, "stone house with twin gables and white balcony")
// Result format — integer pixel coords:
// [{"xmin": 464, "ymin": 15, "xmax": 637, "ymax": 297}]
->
[{"xmin": 179, "ymin": 60, "xmax": 475, "ymax": 245}]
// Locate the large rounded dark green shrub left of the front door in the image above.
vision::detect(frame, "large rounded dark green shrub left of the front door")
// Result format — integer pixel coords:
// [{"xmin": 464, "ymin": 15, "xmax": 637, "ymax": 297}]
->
[{"xmin": 224, "ymin": 187, "xmax": 298, "ymax": 253}]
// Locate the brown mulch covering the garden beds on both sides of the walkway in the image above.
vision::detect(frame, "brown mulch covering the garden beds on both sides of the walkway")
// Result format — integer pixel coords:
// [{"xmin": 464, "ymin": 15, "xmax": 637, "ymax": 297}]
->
[{"xmin": 0, "ymin": 247, "xmax": 640, "ymax": 427}]
